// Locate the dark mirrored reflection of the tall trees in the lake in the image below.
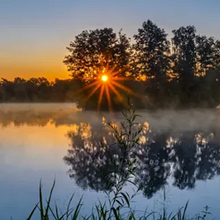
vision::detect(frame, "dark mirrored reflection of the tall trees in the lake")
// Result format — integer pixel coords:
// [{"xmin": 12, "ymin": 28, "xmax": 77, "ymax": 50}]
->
[{"xmin": 64, "ymin": 117, "xmax": 220, "ymax": 198}]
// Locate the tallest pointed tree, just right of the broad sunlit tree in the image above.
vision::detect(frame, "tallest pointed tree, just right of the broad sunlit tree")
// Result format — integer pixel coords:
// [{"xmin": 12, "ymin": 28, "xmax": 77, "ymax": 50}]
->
[{"xmin": 133, "ymin": 20, "xmax": 170, "ymax": 108}]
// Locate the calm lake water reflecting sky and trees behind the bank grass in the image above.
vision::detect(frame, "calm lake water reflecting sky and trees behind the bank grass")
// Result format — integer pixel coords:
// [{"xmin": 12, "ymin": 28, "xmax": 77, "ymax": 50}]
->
[{"xmin": 0, "ymin": 104, "xmax": 220, "ymax": 220}]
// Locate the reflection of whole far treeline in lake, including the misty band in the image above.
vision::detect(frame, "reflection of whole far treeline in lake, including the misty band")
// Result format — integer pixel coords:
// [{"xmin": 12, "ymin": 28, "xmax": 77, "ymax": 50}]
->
[{"xmin": 0, "ymin": 104, "xmax": 220, "ymax": 198}]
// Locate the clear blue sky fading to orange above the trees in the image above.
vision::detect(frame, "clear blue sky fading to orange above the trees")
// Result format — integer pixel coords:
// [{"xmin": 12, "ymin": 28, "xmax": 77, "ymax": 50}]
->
[{"xmin": 0, "ymin": 0, "xmax": 220, "ymax": 80}]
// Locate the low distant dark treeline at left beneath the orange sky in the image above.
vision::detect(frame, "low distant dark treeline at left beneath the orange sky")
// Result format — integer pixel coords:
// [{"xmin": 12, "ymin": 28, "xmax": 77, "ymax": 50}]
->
[{"xmin": 0, "ymin": 77, "xmax": 79, "ymax": 102}]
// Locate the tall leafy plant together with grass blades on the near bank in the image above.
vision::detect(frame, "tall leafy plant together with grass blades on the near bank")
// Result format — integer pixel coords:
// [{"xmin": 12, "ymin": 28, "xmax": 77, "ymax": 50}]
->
[{"xmin": 27, "ymin": 103, "xmax": 210, "ymax": 220}]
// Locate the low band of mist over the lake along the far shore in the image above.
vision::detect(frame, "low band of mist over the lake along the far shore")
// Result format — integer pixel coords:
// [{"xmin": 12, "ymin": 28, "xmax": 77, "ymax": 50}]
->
[{"xmin": 0, "ymin": 103, "xmax": 220, "ymax": 132}]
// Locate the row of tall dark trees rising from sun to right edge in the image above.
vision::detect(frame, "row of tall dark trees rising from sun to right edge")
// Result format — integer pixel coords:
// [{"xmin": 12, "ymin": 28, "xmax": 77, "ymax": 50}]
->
[{"xmin": 64, "ymin": 20, "xmax": 220, "ymax": 108}]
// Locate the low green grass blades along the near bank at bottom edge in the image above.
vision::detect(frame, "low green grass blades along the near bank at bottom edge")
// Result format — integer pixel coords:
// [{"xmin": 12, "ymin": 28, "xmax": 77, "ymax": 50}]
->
[{"xmin": 27, "ymin": 181, "xmax": 210, "ymax": 220}]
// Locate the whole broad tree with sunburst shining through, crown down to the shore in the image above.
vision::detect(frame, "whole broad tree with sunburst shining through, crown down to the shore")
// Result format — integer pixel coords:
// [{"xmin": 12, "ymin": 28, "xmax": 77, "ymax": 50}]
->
[{"xmin": 64, "ymin": 28, "xmax": 143, "ymax": 110}]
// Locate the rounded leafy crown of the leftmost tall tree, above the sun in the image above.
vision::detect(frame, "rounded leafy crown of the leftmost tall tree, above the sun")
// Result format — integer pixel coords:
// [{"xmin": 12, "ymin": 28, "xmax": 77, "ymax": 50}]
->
[{"xmin": 64, "ymin": 28, "xmax": 130, "ymax": 83}]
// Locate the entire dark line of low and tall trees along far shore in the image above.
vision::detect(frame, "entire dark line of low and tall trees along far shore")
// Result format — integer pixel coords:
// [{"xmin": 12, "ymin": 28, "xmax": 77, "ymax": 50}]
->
[{"xmin": 0, "ymin": 20, "xmax": 220, "ymax": 109}]
